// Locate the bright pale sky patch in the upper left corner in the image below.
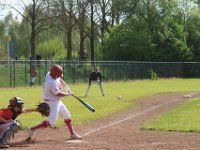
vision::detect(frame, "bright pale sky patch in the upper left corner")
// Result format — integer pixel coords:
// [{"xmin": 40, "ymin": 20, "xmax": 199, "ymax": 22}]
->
[{"xmin": 0, "ymin": 0, "xmax": 30, "ymax": 20}]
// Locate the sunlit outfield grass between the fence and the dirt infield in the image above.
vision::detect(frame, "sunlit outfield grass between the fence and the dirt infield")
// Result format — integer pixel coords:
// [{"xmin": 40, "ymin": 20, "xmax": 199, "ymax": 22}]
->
[{"xmin": 0, "ymin": 79, "xmax": 200, "ymax": 129}]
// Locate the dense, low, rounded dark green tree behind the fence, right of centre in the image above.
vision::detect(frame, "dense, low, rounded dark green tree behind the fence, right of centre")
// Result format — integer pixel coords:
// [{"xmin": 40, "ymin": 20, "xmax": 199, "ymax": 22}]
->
[{"xmin": 102, "ymin": 17, "xmax": 155, "ymax": 61}]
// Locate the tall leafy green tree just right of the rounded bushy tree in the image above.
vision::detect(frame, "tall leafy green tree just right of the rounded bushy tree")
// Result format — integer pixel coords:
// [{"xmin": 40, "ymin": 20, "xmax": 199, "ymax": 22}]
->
[{"xmin": 138, "ymin": 0, "xmax": 191, "ymax": 61}]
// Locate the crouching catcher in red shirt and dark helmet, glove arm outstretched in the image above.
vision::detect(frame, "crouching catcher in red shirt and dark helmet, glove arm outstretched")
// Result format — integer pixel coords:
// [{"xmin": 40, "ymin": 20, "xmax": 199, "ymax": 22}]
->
[{"xmin": 0, "ymin": 97, "xmax": 50, "ymax": 148}]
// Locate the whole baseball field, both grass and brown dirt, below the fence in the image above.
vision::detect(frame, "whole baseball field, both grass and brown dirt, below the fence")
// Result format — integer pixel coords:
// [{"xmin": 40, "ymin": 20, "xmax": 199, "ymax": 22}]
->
[{"xmin": 0, "ymin": 79, "xmax": 200, "ymax": 150}]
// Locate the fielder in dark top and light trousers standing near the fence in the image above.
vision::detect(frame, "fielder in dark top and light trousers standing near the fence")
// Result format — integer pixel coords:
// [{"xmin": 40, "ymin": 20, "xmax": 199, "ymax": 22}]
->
[{"xmin": 85, "ymin": 67, "xmax": 105, "ymax": 96}]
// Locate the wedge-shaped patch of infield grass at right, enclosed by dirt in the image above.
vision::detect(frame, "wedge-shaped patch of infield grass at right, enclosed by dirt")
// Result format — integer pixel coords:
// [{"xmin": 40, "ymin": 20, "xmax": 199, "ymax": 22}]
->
[{"xmin": 143, "ymin": 99, "xmax": 200, "ymax": 132}]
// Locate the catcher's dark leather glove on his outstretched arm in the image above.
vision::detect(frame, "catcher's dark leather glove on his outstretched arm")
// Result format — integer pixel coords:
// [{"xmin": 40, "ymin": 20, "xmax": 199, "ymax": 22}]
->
[{"xmin": 36, "ymin": 102, "xmax": 50, "ymax": 117}]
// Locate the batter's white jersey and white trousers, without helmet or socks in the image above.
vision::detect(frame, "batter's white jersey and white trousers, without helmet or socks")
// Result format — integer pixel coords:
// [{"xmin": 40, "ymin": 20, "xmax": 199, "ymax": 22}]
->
[{"xmin": 43, "ymin": 72, "xmax": 71, "ymax": 126}]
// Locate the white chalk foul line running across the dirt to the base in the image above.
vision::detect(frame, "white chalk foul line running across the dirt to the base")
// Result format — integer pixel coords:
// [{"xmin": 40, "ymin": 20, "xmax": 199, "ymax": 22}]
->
[{"xmin": 83, "ymin": 92, "xmax": 198, "ymax": 136}]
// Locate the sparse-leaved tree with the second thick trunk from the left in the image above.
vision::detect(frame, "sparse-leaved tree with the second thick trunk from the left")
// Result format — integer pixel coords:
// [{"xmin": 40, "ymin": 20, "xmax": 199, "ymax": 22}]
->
[{"xmin": 45, "ymin": 0, "xmax": 77, "ymax": 60}]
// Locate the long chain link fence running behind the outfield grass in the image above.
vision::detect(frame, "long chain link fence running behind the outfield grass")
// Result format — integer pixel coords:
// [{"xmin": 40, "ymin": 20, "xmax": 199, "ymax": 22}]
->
[{"xmin": 0, "ymin": 60, "xmax": 200, "ymax": 87}]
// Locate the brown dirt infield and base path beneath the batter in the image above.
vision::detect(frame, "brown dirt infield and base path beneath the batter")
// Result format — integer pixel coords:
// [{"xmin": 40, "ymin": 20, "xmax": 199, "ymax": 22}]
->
[{"xmin": 9, "ymin": 93, "xmax": 200, "ymax": 150}]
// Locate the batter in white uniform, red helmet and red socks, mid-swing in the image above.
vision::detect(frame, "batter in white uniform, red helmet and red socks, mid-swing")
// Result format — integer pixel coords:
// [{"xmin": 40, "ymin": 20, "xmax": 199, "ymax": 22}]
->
[{"xmin": 27, "ymin": 65, "xmax": 82, "ymax": 141}]
